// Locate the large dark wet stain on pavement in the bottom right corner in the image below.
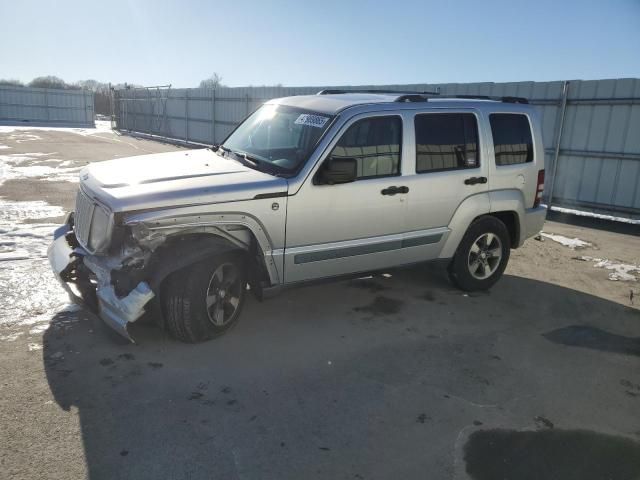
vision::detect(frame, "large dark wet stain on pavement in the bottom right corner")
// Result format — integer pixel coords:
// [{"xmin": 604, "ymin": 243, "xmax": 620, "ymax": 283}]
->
[{"xmin": 464, "ymin": 429, "xmax": 640, "ymax": 480}]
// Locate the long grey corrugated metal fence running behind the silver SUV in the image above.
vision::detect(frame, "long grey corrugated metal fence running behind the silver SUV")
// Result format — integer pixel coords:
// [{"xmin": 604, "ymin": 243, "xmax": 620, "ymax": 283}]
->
[{"xmin": 114, "ymin": 78, "xmax": 640, "ymax": 218}]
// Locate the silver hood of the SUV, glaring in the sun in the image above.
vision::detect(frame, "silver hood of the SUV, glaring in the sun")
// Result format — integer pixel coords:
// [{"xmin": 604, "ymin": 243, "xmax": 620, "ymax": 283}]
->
[{"xmin": 80, "ymin": 149, "xmax": 288, "ymax": 212}]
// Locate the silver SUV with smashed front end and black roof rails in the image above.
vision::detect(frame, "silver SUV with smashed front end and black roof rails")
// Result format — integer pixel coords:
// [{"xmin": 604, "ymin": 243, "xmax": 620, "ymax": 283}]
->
[{"xmin": 49, "ymin": 90, "xmax": 546, "ymax": 342}]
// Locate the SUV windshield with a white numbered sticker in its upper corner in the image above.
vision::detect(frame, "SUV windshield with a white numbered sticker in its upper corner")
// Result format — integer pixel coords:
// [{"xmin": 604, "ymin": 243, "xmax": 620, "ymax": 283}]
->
[{"xmin": 222, "ymin": 105, "xmax": 332, "ymax": 173}]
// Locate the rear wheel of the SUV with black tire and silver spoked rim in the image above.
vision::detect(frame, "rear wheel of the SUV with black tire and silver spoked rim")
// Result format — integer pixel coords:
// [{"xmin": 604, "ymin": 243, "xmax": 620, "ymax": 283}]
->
[{"xmin": 449, "ymin": 216, "xmax": 511, "ymax": 292}]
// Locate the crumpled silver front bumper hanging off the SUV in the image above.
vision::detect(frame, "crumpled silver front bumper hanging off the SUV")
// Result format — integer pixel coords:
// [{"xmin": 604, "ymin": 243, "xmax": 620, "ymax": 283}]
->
[{"xmin": 48, "ymin": 217, "xmax": 154, "ymax": 342}]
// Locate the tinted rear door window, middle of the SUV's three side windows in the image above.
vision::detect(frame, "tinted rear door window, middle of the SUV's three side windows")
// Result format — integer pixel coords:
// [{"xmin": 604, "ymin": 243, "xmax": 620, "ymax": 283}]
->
[{"xmin": 415, "ymin": 113, "xmax": 480, "ymax": 173}]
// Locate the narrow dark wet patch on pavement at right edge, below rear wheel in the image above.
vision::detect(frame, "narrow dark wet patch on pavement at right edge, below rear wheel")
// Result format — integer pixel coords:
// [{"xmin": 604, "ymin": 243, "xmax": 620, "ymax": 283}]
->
[{"xmin": 542, "ymin": 325, "xmax": 640, "ymax": 357}]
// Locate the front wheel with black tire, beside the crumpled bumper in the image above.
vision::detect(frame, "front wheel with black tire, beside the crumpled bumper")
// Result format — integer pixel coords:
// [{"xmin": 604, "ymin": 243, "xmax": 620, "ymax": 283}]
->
[{"xmin": 162, "ymin": 254, "xmax": 247, "ymax": 343}]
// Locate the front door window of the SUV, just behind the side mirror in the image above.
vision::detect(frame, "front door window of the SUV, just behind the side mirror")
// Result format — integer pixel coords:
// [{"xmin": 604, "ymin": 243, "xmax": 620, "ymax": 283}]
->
[{"xmin": 329, "ymin": 117, "xmax": 402, "ymax": 179}]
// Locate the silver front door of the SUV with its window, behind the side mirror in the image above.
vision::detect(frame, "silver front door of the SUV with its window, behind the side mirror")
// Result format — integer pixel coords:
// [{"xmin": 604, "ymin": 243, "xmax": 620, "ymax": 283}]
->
[{"xmin": 284, "ymin": 114, "xmax": 406, "ymax": 283}]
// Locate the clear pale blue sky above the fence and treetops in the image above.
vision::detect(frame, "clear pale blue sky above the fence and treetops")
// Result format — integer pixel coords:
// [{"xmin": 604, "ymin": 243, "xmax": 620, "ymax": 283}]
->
[{"xmin": 0, "ymin": 0, "xmax": 640, "ymax": 87}]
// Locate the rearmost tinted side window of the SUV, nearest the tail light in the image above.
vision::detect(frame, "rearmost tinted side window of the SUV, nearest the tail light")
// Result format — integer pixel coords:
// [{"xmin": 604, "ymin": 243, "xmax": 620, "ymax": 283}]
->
[{"xmin": 489, "ymin": 113, "xmax": 533, "ymax": 166}]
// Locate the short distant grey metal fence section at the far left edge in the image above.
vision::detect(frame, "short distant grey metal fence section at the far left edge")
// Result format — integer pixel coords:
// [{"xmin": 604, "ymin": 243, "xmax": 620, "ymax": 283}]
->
[{"xmin": 0, "ymin": 85, "xmax": 95, "ymax": 127}]
